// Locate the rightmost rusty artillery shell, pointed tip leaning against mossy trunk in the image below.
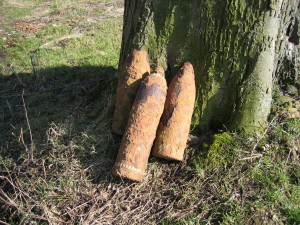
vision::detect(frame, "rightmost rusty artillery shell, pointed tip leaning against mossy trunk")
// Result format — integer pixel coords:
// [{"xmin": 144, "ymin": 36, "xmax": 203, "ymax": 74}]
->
[{"xmin": 152, "ymin": 62, "xmax": 196, "ymax": 161}]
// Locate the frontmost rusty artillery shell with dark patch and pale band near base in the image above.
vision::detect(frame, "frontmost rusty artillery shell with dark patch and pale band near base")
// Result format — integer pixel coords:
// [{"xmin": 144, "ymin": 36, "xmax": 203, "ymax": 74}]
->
[{"xmin": 112, "ymin": 69, "xmax": 167, "ymax": 182}]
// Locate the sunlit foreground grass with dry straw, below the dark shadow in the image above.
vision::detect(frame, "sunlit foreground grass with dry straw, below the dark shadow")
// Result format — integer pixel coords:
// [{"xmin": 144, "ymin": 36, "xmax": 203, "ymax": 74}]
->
[{"xmin": 0, "ymin": 95, "xmax": 300, "ymax": 224}]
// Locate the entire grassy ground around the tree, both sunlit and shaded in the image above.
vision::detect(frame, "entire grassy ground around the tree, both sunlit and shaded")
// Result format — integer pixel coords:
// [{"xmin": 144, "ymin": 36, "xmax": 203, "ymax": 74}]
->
[{"xmin": 0, "ymin": 0, "xmax": 300, "ymax": 225}]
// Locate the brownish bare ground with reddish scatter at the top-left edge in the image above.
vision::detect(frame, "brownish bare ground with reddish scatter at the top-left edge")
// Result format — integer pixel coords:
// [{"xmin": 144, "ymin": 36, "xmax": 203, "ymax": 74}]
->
[{"xmin": 0, "ymin": 0, "xmax": 124, "ymax": 42}]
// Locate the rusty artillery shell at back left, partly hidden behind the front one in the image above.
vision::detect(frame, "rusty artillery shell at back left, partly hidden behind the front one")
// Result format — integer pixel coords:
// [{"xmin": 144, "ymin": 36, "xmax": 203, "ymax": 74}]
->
[{"xmin": 112, "ymin": 50, "xmax": 150, "ymax": 135}]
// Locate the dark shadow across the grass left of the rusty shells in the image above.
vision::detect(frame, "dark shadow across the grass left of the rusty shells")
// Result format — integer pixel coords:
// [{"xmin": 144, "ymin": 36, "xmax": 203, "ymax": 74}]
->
[{"xmin": 0, "ymin": 66, "xmax": 120, "ymax": 183}]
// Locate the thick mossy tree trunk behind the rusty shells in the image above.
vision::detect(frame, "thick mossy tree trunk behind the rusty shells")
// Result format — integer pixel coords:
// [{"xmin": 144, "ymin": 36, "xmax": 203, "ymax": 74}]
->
[{"xmin": 119, "ymin": 0, "xmax": 300, "ymax": 133}]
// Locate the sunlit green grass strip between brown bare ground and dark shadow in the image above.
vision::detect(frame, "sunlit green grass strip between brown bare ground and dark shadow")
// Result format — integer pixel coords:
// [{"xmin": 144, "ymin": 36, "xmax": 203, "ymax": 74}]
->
[{"xmin": 0, "ymin": 7, "xmax": 122, "ymax": 74}]
